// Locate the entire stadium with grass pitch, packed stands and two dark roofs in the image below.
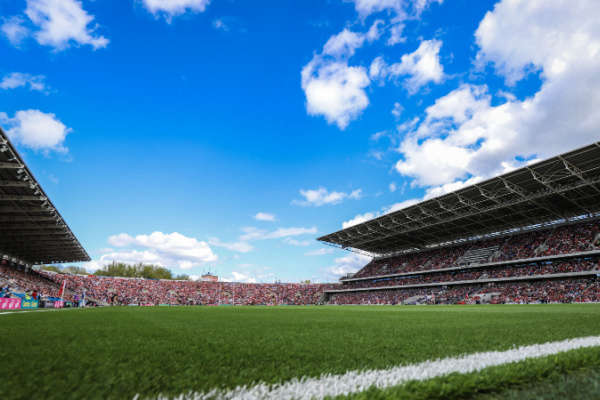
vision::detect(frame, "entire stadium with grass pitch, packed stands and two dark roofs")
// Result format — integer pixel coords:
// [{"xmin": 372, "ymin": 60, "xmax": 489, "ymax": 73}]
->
[{"xmin": 0, "ymin": 124, "xmax": 600, "ymax": 398}]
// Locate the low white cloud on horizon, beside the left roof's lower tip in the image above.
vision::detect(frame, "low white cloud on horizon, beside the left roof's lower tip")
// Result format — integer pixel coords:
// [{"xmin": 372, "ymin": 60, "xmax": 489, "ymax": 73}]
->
[{"xmin": 100, "ymin": 232, "xmax": 217, "ymax": 269}]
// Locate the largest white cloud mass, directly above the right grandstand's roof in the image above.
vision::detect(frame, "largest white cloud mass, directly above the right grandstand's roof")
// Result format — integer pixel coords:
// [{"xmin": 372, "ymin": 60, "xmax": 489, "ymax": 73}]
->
[{"xmin": 396, "ymin": 0, "xmax": 600, "ymax": 194}]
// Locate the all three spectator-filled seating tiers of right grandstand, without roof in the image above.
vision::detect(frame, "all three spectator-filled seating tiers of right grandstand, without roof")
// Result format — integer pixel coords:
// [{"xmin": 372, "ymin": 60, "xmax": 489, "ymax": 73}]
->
[{"xmin": 329, "ymin": 221, "xmax": 600, "ymax": 304}]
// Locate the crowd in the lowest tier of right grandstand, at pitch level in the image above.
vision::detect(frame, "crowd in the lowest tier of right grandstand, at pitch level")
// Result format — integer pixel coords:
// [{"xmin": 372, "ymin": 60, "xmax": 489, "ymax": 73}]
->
[{"xmin": 328, "ymin": 278, "xmax": 600, "ymax": 304}]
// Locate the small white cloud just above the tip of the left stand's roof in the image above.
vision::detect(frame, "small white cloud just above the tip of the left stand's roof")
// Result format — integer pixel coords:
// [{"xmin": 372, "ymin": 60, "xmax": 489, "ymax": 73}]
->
[{"xmin": 0, "ymin": 110, "xmax": 71, "ymax": 153}]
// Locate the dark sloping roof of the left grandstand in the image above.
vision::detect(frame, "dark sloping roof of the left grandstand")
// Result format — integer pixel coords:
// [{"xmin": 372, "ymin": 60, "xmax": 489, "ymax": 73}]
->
[{"xmin": 0, "ymin": 129, "xmax": 90, "ymax": 264}]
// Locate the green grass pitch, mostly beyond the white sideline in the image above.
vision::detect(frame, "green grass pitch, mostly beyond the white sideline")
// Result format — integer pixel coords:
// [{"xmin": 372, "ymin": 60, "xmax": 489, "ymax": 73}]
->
[{"xmin": 0, "ymin": 304, "xmax": 600, "ymax": 399}]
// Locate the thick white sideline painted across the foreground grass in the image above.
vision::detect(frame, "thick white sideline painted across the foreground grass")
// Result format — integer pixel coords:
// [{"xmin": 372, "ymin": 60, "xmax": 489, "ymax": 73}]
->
[{"xmin": 156, "ymin": 336, "xmax": 600, "ymax": 400}]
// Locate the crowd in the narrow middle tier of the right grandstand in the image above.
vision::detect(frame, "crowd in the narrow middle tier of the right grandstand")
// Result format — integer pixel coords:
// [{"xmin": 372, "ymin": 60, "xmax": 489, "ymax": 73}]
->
[{"xmin": 342, "ymin": 259, "xmax": 600, "ymax": 289}]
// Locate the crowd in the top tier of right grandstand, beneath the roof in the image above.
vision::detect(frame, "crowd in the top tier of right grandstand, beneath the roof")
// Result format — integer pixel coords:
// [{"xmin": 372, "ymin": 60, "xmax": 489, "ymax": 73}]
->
[{"xmin": 352, "ymin": 221, "xmax": 600, "ymax": 278}]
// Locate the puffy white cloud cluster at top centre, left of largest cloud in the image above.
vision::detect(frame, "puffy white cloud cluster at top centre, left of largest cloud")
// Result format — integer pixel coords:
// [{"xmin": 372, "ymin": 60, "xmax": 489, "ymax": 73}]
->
[{"xmin": 301, "ymin": 0, "xmax": 443, "ymax": 130}]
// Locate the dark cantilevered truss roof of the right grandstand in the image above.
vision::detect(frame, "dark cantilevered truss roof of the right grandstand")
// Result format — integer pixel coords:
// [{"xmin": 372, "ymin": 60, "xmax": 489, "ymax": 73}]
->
[{"xmin": 319, "ymin": 142, "xmax": 600, "ymax": 254}]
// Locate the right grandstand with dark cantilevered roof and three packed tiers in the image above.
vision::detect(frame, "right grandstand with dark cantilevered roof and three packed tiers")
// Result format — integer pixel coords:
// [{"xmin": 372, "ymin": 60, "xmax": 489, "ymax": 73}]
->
[{"xmin": 319, "ymin": 142, "xmax": 600, "ymax": 304}]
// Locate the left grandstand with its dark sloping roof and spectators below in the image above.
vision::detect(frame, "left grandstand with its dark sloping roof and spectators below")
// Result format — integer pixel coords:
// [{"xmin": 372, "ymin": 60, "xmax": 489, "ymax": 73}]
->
[{"xmin": 0, "ymin": 129, "xmax": 90, "ymax": 306}]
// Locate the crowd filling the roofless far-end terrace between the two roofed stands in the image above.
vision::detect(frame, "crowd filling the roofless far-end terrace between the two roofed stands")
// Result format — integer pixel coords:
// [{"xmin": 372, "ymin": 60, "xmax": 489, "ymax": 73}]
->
[{"xmin": 37, "ymin": 273, "xmax": 337, "ymax": 305}]
